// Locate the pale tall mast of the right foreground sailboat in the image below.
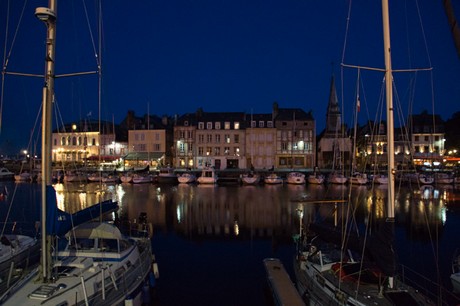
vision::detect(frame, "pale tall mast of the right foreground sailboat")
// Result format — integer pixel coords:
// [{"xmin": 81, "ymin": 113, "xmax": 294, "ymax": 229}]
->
[{"xmin": 382, "ymin": 0, "xmax": 395, "ymax": 219}]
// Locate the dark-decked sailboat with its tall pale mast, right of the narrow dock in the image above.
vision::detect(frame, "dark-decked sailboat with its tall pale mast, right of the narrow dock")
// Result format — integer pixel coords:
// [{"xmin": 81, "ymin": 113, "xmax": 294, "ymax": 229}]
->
[{"xmin": 294, "ymin": 0, "xmax": 434, "ymax": 305}]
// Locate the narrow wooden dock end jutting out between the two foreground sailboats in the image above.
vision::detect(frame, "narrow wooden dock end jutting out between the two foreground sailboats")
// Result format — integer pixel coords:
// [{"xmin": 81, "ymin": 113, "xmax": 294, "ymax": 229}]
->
[{"xmin": 264, "ymin": 258, "xmax": 305, "ymax": 306}]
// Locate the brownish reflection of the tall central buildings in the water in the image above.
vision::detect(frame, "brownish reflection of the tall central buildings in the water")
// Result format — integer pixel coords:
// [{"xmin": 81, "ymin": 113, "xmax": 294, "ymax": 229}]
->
[{"xmin": 169, "ymin": 185, "xmax": 298, "ymax": 238}]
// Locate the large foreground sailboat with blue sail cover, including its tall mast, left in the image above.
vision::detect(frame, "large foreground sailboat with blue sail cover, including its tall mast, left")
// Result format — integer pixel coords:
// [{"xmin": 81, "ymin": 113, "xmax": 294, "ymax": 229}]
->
[{"xmin": 0, "ymin": 0, "xmax": 157, "ymax": 305}]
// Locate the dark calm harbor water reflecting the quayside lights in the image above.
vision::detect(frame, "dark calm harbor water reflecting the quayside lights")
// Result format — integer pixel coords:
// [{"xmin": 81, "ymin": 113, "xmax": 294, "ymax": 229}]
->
[{"xmin": 0, "ymin": 182, "xmax": 460, "ymax": 306}]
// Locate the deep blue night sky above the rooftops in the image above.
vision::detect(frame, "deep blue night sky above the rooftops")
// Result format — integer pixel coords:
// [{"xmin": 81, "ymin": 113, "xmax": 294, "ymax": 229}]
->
[{"xmin": 0, "ymin": 0, "xmax": 460, "ymax": 154}]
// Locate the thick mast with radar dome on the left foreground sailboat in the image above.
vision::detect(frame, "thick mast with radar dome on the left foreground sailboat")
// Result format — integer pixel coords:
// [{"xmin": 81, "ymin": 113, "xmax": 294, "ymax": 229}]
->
[{"xmin": 35, "ymin": 0, "xmax": 57, "ymax": 281}]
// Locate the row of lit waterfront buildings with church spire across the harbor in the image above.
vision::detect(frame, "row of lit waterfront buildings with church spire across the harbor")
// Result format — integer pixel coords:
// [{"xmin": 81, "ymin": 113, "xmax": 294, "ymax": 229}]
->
[{"xmin": 52, "ymin": 78, "xmax": 445, "ymax": 169}]
